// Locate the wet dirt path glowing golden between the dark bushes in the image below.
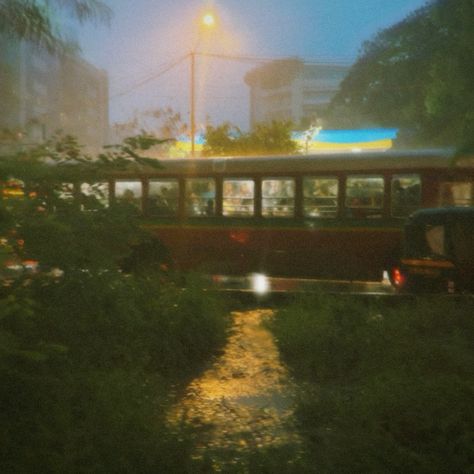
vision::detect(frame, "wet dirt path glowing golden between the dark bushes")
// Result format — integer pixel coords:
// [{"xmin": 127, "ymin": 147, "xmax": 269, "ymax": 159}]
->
[{"xmin": 170, "ymin": 310, "xmax": 299, "ymax": 464}]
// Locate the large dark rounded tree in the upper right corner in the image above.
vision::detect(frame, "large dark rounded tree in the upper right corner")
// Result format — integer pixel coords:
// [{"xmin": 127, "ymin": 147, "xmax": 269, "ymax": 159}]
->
[{"xmin": 332, "ymin": 0, "xmax": 474, "ymax": 146}]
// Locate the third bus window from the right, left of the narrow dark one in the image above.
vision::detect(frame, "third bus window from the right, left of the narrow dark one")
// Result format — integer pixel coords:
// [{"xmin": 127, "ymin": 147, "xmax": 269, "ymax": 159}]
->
[{"xmin": 346, "ymin": 176, "xmax": 384, "ymax": 217}]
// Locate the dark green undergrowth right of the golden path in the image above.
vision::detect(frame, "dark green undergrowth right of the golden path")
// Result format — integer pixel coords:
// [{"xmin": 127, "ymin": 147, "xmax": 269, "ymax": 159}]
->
[{"xmin": 273, "ymin": 296, "xmax": 474, "ymax": 473}]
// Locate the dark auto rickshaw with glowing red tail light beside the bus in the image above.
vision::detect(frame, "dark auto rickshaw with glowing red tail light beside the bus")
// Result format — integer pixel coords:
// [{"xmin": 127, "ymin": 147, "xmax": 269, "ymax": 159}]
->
[{"xmin": 391, "ymin": 207, "xmax": 474, "ymax": 292}]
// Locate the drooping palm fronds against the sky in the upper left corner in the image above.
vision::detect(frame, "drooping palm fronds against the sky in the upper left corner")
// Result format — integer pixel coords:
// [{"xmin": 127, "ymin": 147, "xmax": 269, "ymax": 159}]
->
[{"xmin": 0, "ymin": 0, "xmax": 111, "ymax": 54}]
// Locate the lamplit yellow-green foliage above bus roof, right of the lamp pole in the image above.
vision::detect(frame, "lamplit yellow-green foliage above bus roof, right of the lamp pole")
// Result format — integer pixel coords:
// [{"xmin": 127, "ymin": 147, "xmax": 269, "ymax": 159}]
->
[{"xmin": 203, "ymin": 121, "xmax": 297, "ymax": 156}]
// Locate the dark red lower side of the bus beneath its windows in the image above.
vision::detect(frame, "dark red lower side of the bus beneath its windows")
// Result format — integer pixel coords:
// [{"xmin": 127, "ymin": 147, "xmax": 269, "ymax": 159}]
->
[{"xmin": 146, "ymin": 220, "xmax": 401, "ymax": 280}]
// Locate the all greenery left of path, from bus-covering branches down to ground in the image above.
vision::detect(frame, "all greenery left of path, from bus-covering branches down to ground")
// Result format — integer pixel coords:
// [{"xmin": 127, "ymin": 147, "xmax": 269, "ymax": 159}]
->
[{"xmin": 0, "ymin": 137, "xmax": 229, "ymax": 473}]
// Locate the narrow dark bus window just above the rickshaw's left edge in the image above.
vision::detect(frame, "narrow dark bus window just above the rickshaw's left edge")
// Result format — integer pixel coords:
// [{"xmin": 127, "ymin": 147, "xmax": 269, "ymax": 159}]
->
[{"xmin": 391, "ymin": 174, "xmax": 421, "ymax": 217}]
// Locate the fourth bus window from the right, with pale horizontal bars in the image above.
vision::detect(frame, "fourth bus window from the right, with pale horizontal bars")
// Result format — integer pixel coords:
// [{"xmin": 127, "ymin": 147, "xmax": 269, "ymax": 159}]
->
[{"xmin": 303, "ymin": 177, "xmax": 339, "ymax": 217}]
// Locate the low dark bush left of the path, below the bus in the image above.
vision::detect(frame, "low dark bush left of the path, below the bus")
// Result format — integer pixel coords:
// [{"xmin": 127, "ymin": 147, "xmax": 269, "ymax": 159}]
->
[{"xmin": 0, "ymin": 271, "xmax": 228, "ymax": 473}]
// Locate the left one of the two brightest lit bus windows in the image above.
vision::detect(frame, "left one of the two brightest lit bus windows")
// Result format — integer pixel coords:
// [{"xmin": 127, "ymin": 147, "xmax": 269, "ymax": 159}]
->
[{"xmin": 222, "ymin": 179, "xmax": 255, "ymax": 216}]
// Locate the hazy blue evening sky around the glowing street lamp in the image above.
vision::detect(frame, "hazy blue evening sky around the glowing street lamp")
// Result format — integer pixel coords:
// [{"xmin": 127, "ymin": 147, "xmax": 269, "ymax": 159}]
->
[{"xmin": 79, "ymin": 0, "xmax": 426, "ymax": 129}]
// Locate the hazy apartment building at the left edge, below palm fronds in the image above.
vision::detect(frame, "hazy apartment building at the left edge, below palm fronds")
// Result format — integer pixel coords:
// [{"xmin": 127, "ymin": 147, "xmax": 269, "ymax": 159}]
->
[{"xmin": 0, "ymin": 38, "xmax": 109, "ymax": 149}]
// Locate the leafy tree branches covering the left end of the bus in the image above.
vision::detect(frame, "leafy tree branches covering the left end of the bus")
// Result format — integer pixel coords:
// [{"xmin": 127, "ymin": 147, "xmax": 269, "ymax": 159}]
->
[{"xmin": 0, "ymin": 134, "xmax": 167, "ymax": 271}]
